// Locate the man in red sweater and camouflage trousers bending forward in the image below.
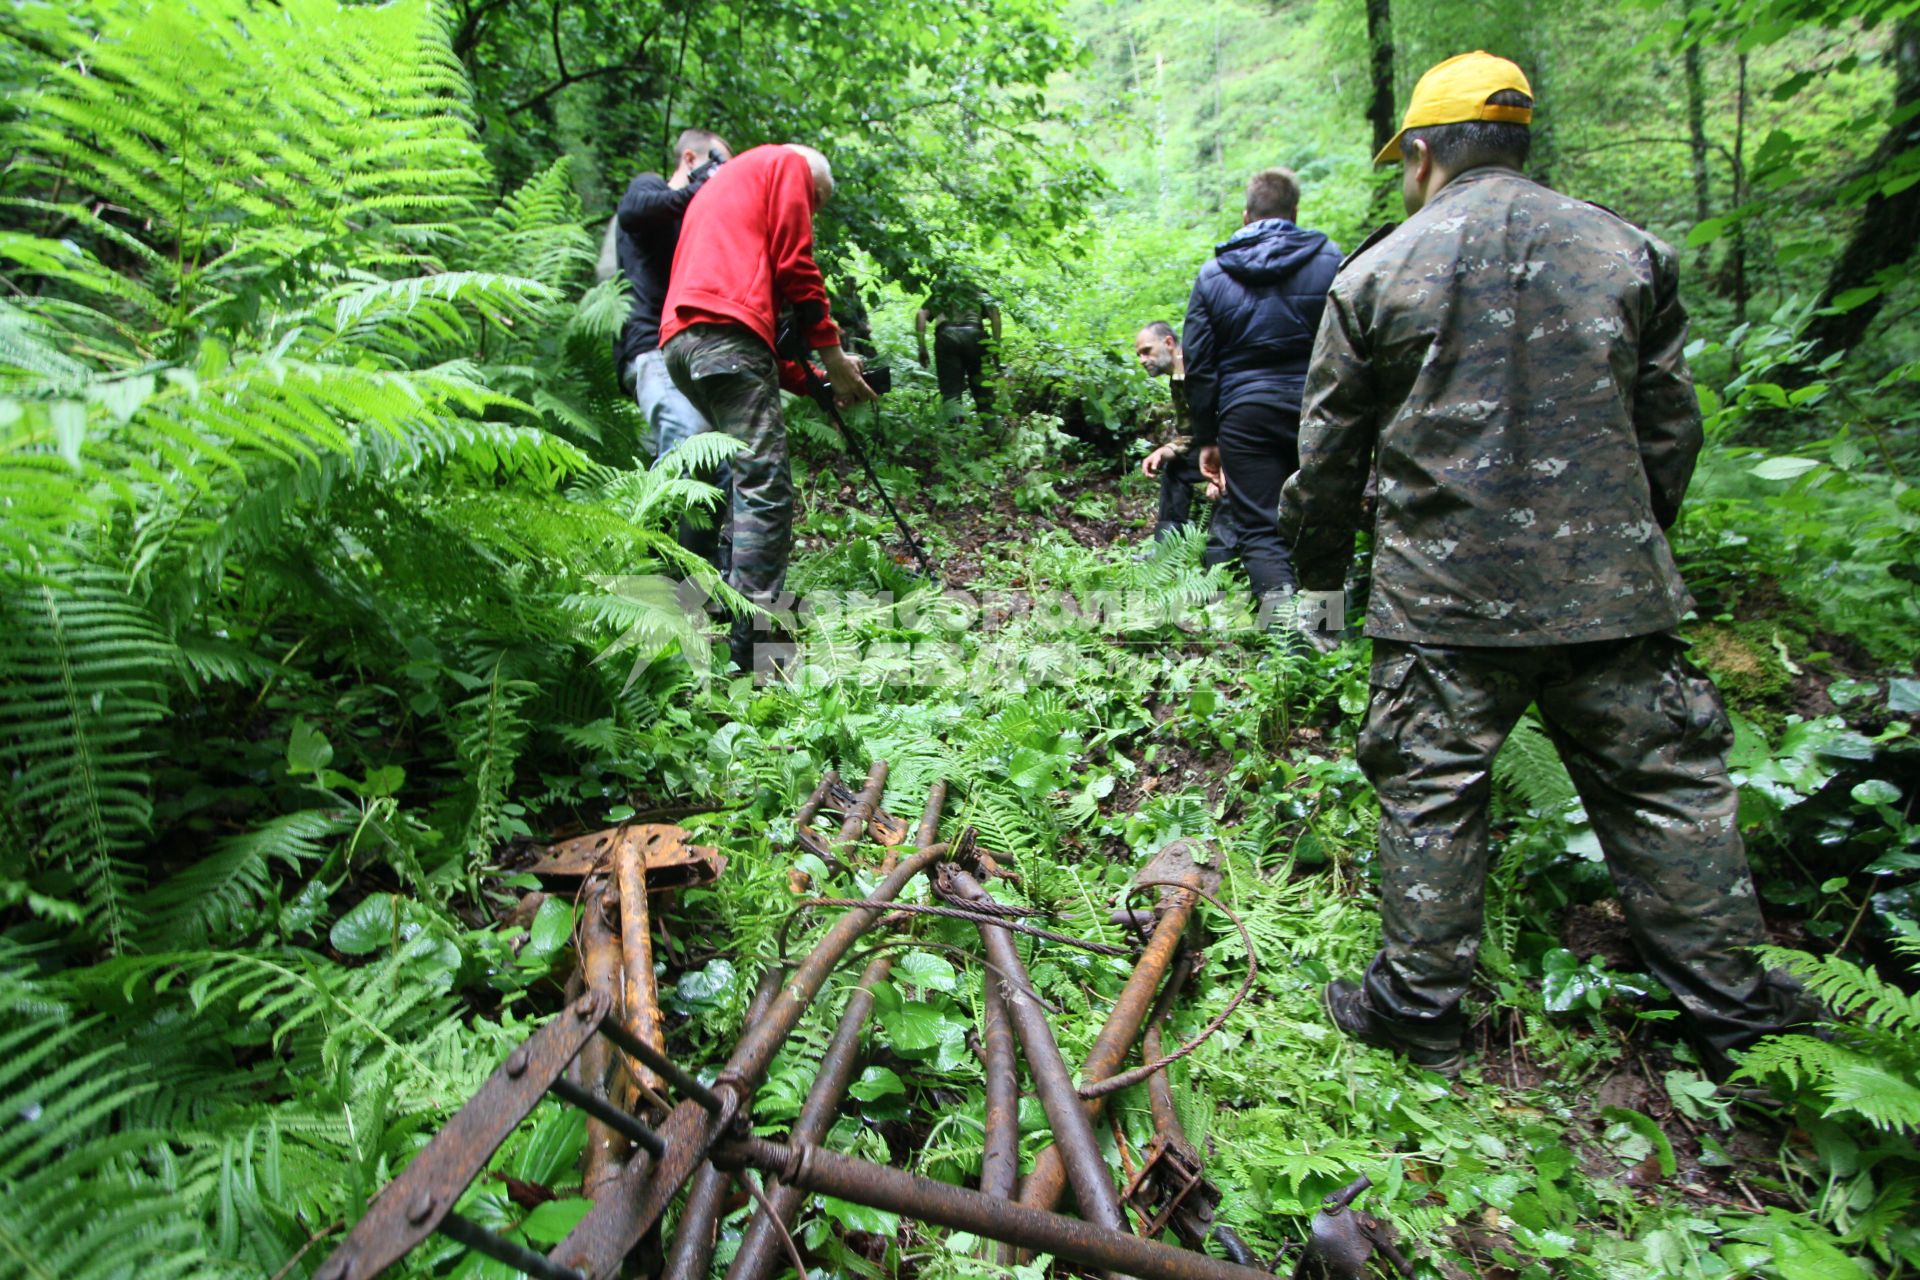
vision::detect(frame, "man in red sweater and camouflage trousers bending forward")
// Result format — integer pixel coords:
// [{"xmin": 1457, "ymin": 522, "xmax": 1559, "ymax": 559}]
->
[{"xmin": 660, "ymin": 142, "xmax": 874, "ymax": 672}]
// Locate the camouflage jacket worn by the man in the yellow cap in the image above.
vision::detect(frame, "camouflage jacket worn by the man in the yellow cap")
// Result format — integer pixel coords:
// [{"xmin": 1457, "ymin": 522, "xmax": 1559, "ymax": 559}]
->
[{"xmin": 1281, "ymin": 169, "xmax": 1701, "ymax": 647}]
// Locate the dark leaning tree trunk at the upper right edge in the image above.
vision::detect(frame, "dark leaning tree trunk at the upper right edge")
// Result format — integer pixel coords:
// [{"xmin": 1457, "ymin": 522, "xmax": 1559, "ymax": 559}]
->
[{"xmin": 1805, "ymin": 17, "xmax": 1920, "ymax": 353}]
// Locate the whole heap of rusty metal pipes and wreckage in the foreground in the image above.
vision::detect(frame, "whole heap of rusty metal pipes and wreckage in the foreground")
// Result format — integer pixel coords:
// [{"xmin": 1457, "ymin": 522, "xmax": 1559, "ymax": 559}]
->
[{"xmin": 313, "ymin": 760, "xmax": 1413, "ymax": 1280}]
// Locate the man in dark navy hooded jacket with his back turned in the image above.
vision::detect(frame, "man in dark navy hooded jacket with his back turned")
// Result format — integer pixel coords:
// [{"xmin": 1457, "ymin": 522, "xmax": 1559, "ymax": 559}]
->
[{"xmin": 1185, "ymin": 169, "xmax": 1340, "ymax": 616}]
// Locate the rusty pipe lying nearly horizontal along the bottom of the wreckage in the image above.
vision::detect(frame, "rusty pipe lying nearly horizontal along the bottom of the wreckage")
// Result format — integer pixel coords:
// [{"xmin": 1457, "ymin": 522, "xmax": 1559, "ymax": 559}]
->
[{"xmin": 712, "ymin": 1138, "xmax": 1273, "ymax": 1280}]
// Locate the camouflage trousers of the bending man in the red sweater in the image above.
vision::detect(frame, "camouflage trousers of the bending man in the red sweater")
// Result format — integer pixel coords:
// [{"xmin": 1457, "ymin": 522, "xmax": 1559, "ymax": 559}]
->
[{"xmin": 664, "ymin": 324, "xmax": 793, "ymax": 670}]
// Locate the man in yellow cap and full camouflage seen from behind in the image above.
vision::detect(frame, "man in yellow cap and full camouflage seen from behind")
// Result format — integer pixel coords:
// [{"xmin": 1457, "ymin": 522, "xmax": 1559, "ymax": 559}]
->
[{"xmin": 1281, "ymin": 52, "xmax": 1811, "ymax": 1073}]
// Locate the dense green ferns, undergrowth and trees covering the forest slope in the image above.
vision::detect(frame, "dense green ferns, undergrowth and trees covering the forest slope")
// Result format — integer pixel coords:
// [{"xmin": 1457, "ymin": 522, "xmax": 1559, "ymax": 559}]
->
[{"xmin": 0, "ymin": 0, "xmax": 1920, "ymax": 1280}]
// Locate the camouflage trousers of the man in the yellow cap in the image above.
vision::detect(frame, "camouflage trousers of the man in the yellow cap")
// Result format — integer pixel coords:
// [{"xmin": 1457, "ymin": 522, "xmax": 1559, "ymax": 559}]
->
[{"xmin": 1357, "ymin": 633, "xmax": 1801, "ymax": 1054}]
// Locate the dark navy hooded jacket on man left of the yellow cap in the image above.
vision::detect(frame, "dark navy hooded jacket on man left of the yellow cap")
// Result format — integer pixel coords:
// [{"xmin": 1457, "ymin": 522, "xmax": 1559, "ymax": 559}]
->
[{"xmin": 1181, "ymin": 217, "xmax": 1340, "ymax": 445}]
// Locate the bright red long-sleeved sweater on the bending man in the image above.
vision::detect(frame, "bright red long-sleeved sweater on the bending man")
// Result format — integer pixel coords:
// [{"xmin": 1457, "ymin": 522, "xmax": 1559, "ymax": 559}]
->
[{"xmin": 660, "ymin": 146, "xmax": 839, "ymax": 380}]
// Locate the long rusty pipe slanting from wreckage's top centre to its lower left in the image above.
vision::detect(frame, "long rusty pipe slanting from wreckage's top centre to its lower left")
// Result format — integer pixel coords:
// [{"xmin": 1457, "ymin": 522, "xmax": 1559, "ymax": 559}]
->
[{"xmin": 547, "ymin": 844, "xmax": 947, "ymax": 1280}]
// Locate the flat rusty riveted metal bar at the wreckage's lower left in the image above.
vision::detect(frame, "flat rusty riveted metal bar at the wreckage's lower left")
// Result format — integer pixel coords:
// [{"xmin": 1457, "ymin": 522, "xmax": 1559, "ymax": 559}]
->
[{"xmin": 313, "ymin": 990, "xmax": 612, "ymax": 1280}]
